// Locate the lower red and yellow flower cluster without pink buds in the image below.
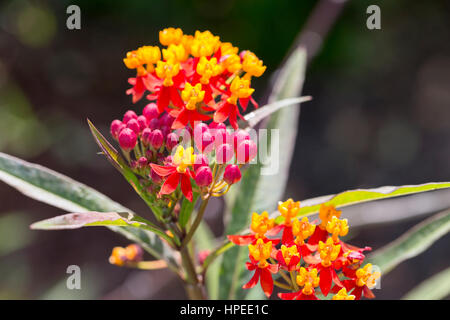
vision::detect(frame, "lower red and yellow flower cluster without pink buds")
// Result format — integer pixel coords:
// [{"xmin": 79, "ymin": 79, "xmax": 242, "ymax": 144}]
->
[{"xmin": 228, "ymin": 199, "xmax": 380, "ymax": 300}]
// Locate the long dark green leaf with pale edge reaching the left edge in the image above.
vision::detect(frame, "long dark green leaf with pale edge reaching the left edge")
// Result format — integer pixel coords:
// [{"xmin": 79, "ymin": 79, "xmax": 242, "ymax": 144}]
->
[{"xmin": 0, "ymin": 153, "xmax": 177, "ymax": 270}]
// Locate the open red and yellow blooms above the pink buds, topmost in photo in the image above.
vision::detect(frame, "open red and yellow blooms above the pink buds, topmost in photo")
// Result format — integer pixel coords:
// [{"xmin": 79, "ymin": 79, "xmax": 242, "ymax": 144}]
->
[{"xmin": 123, "ymin": 28, "xmax": 266, "ymax": 129}]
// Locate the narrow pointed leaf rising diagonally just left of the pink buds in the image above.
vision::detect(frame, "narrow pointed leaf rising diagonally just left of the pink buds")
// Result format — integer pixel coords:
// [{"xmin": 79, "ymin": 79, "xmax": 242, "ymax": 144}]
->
[{"xmin": 87, "ymin": 119, "xmax": 163, "ymax": 220}]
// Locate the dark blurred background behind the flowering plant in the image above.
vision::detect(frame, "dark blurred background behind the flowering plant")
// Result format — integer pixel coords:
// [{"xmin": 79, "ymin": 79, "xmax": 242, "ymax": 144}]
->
[{"xmin": 0, "ymin": 0, "xmax": 450, "ymax": 299}]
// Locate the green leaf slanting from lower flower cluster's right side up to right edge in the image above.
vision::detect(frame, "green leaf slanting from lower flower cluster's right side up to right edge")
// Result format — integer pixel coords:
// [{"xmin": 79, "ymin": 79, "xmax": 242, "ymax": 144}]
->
[{"xmin": 368, "ymin": 209, "xmax": 450, "ymax": 275}]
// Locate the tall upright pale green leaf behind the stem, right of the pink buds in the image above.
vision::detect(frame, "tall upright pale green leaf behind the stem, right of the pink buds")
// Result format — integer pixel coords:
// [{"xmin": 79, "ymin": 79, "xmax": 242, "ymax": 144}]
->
[{"xmin": 219, "ymin": 48, "xmax": 306, "ymax": 299}]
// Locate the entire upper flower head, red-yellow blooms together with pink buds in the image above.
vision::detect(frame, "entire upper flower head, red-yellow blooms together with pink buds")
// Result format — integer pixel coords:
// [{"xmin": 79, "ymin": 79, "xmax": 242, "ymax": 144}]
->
[{"xmin": 110, "ymin": 28, "xmax": 260, "ymax": 203}]
